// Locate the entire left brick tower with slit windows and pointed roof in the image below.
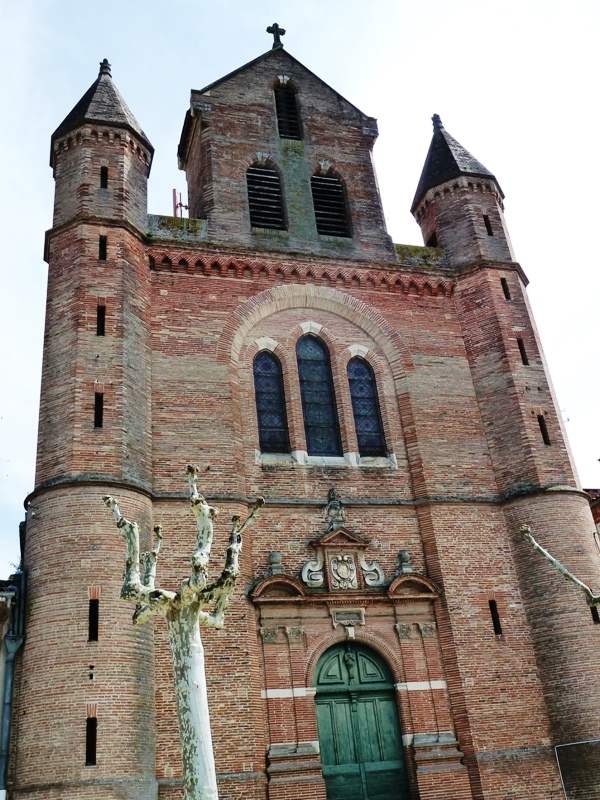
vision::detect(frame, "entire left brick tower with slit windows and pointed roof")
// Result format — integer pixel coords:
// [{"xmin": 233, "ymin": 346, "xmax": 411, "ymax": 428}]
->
[{"xmin": 13, "ymin": 59, "xmax": 157, "ymax": 800}]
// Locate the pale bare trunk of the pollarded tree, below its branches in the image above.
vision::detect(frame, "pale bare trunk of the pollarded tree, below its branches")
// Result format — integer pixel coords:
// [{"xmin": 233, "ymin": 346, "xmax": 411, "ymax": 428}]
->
[{"xmin": 168, "ymin": 603, "xmax": 219, "ymax": 800}]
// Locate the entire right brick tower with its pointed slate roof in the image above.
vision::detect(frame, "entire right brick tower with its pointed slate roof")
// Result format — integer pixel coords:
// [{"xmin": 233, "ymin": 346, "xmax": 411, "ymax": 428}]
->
[{"xmin": 412, "ymin": 115, "xmax": 600, "ymax": 772}]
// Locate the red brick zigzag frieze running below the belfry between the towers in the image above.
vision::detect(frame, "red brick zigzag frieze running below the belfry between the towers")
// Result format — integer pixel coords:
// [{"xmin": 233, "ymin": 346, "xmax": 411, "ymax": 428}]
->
[{"xmin": 148, "ymin": 249, "xmax": 454, "ymax": 297}]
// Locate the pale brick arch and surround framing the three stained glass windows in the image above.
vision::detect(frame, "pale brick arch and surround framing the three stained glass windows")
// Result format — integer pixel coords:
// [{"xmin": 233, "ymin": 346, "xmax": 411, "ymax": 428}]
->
[{"xmin": 232, "ymin": 286, "xmax": 412, "ymax": 466}]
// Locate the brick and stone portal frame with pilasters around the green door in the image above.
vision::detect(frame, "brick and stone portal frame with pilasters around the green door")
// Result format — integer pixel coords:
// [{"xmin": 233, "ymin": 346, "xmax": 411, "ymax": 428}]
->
[{"xmin": 250, "ymin": 573, "xmax": 472, "ymax": 800}]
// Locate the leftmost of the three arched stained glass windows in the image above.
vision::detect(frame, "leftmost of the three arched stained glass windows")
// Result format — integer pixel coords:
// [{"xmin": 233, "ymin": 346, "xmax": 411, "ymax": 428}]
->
[{"xmin": 254, "ymin": 350, "xmax": 290, "ymax": 453}]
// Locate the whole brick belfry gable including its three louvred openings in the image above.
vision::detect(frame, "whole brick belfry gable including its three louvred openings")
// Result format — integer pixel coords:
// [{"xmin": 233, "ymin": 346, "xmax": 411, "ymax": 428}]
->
[{"xmin": 178, "ymin": 47, "xmax": 395, "ymax": 260}]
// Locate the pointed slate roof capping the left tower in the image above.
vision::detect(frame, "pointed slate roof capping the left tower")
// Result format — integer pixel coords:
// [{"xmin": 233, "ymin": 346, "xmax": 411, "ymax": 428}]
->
[{"xmin": 50, "ymin": 58, "xmax": 154, "ymax": 166}]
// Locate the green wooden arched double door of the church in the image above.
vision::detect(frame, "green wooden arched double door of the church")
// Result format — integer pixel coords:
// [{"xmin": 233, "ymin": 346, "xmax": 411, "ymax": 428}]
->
[{"xmin": 315, "ymin": 642, "xmax": 409, "ymax": 800}]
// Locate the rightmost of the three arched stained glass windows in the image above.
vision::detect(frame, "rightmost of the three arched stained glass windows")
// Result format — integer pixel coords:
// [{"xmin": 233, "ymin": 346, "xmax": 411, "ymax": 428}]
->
[{"xmin": 348, "ymin": 358, "xmax": 387, "ymax": 456}]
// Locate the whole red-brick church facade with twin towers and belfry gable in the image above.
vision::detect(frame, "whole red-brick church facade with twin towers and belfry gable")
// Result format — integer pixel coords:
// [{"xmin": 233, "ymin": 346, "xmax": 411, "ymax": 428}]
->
[{"xmin": 8, "ymin": 34, "xmax": 600, "ymax": 800}]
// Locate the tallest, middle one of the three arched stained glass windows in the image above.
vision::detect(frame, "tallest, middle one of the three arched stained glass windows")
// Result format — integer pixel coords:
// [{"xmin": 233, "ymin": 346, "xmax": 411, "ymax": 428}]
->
[{"xmin": 296, "ymin": 334, "xmax": 342, "ymax": 456}]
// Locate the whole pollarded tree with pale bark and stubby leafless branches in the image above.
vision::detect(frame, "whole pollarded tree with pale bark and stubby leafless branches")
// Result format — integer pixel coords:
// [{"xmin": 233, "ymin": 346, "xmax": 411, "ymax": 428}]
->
[{"xmin": 103, "ymin": 465, "xmax": 264, "ymax": 800}]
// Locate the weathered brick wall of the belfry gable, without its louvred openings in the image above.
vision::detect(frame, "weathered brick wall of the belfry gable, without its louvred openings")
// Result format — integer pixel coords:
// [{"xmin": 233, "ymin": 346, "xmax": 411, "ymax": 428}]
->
[{"xmin": 179, "ymin": 50, "xmax": 393, "ymax": 259}]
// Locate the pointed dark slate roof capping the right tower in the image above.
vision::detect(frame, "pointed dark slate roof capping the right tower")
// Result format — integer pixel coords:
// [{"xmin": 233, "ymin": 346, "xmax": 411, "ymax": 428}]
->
[{"xmin": 411, "ymin": 114, "xmax": 504, "ymax": 211}]
